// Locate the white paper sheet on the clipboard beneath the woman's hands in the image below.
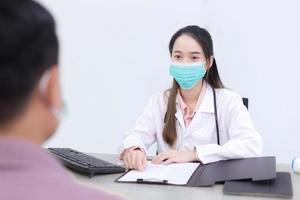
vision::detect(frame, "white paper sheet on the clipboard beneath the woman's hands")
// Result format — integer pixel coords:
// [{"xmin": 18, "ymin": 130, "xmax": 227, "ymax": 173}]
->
[{"xmin": 118, "ymin": 162, "xmax": 200, "ymax": 185}]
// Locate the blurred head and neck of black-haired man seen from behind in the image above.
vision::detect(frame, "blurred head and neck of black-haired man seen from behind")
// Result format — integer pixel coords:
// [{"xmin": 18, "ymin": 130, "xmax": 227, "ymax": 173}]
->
[{"xmin": 0, "ymin": 0, "xmax": 61, "ymax": 143}]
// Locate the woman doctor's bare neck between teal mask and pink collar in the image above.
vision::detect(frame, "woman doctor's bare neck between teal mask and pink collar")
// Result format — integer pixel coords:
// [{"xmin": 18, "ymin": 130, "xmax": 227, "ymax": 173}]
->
[{"xmin": 180, "ymin": 80, "xmax": 204, "ymax": 105}]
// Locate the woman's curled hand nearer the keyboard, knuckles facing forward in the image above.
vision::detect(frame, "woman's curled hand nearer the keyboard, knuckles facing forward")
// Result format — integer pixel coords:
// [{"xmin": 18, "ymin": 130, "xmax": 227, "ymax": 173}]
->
[{"xmin": 123, "ymin": 149, "xmax": 147, "ymax": 171}]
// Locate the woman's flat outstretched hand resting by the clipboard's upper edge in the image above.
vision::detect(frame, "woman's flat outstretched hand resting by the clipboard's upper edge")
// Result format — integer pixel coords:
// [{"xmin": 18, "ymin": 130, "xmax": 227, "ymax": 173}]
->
[{"xmin": 152, "ymin": 150, "xmax": 198, "ymax": 164}]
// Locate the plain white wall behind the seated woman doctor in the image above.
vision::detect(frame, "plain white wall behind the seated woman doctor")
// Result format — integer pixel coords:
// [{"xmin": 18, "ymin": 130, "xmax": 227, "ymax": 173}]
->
[{"xmin": 40, "ymin": 0, "xmax": 300, "ymax": 162}]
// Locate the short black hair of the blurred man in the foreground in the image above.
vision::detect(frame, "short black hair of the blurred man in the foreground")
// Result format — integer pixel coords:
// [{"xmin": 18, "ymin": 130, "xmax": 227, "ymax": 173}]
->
[{"xmin": 0, "ymin": 0, "xmax": 58, "ymax": 125}]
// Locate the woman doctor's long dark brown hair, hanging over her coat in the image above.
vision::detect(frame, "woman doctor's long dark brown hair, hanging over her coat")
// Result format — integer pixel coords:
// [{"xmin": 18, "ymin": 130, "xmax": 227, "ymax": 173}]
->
[{"xmin": 163, "ymin": 26, "xmax": 224, "ymax": 147}]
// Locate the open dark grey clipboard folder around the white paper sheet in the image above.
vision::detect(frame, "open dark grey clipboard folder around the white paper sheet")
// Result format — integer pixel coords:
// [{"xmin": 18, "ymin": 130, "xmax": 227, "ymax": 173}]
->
[{"xmin": 115, "ymin": 156, "xmax": 277, "ymax": 187}]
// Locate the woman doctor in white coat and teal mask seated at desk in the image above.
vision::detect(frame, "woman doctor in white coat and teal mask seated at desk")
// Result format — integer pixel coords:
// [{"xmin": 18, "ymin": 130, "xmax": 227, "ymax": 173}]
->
[{"xmin": 120, "ymin": 26, "xmax": 262, "ymax": 171}]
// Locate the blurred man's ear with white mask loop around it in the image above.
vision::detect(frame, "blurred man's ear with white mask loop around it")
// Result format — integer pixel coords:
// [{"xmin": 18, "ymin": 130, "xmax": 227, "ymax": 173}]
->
[{"xmin": 39, "ymin": 65, "xmax": 62, "ymax": 108}]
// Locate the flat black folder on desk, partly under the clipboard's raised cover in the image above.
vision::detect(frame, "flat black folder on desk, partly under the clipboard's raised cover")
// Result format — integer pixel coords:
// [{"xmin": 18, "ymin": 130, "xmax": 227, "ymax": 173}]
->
[{"xmin": 223, "ymin": 172, "xmax": 293, "ymax": 198}]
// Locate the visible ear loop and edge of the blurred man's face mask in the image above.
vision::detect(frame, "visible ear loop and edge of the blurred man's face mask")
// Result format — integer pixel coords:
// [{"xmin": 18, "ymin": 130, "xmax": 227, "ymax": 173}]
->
[{"xmin": 39, "ymin": 71, "xmax": 66, "ymax": 122}]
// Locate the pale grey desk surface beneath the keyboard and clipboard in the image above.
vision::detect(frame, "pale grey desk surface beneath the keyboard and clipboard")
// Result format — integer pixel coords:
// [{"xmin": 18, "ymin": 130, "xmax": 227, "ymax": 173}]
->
[{"xmin": 71, "ymin": 154, "xmax": 300, "ymax": 200}]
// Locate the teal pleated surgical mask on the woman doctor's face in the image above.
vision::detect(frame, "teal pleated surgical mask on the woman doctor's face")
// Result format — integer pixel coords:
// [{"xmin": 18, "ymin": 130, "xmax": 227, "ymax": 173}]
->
[{"xmin": 170, "ymin": 62, "xmax": 206, "ymax": 90}]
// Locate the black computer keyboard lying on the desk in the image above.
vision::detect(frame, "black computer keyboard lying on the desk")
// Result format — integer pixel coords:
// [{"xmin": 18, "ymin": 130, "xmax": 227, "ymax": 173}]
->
[{"xmin": 49, "ymin": 148, "xmax": 125, "ymax": 177}]
